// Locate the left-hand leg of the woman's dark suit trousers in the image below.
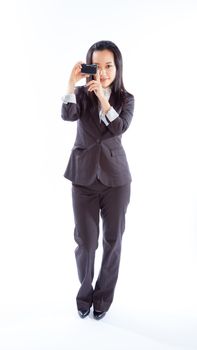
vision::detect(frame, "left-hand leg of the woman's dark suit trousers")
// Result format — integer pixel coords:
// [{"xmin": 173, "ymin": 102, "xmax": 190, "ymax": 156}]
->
[{"xmin": 72, "ymin": 185, "xmax": 99, "ymax": 309}]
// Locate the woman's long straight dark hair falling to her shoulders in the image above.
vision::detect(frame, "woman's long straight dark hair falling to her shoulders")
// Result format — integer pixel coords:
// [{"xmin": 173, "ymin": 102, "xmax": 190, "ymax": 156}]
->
[{"xmin": 76, "ymin": 40, "xmax": 126, "ymax": 113}]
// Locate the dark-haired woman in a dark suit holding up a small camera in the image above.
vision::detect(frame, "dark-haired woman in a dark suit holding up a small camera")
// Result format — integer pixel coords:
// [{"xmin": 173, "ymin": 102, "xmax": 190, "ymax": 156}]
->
[{"xmin": 61, "ymin": 41, "xmax": 134, "ymax": 320}]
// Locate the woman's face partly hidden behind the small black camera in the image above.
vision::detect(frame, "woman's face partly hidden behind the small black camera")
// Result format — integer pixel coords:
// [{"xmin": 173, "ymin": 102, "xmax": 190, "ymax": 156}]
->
[{"xmin": 92, "ymin": 50, "xmax": 116, "ymax": 88}]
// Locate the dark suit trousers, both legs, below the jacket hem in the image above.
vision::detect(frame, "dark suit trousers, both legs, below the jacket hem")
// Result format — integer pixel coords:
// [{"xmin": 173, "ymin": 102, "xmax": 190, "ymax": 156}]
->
[{"xmin": 72, "ymin": 179, "xmax": 130, "ymax": 311}]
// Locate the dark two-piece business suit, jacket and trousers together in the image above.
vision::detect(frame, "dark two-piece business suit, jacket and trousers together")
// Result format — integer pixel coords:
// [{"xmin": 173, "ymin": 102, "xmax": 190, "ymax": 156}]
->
[{"xmin": 61, "ymin": 87, "xmax": 134, "ymax": 311}]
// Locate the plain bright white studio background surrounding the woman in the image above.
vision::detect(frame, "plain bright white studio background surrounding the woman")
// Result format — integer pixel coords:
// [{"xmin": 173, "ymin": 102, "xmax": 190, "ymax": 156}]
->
[{"xmin": 0, "ymin": 0, "xmax": 197, "ymax": 350}]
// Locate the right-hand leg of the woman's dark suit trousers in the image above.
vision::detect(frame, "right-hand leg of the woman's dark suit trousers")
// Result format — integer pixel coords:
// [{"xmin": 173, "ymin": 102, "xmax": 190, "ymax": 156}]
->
[{"xmin": 93, "ymin": 183, "xmax": 130, "ymax": 311}]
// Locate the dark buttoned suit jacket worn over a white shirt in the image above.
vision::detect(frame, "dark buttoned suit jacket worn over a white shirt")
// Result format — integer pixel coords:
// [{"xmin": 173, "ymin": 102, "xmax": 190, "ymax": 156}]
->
[{"xmin": 61, "ymin": 86, "xmax": 134, "ymax": 187}]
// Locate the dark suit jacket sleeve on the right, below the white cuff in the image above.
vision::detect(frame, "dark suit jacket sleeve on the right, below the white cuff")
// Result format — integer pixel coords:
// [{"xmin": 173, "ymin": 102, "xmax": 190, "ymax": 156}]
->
[{"xmin": 107, "ymin": 94, "xmax": 134, "ymax": 135}]
